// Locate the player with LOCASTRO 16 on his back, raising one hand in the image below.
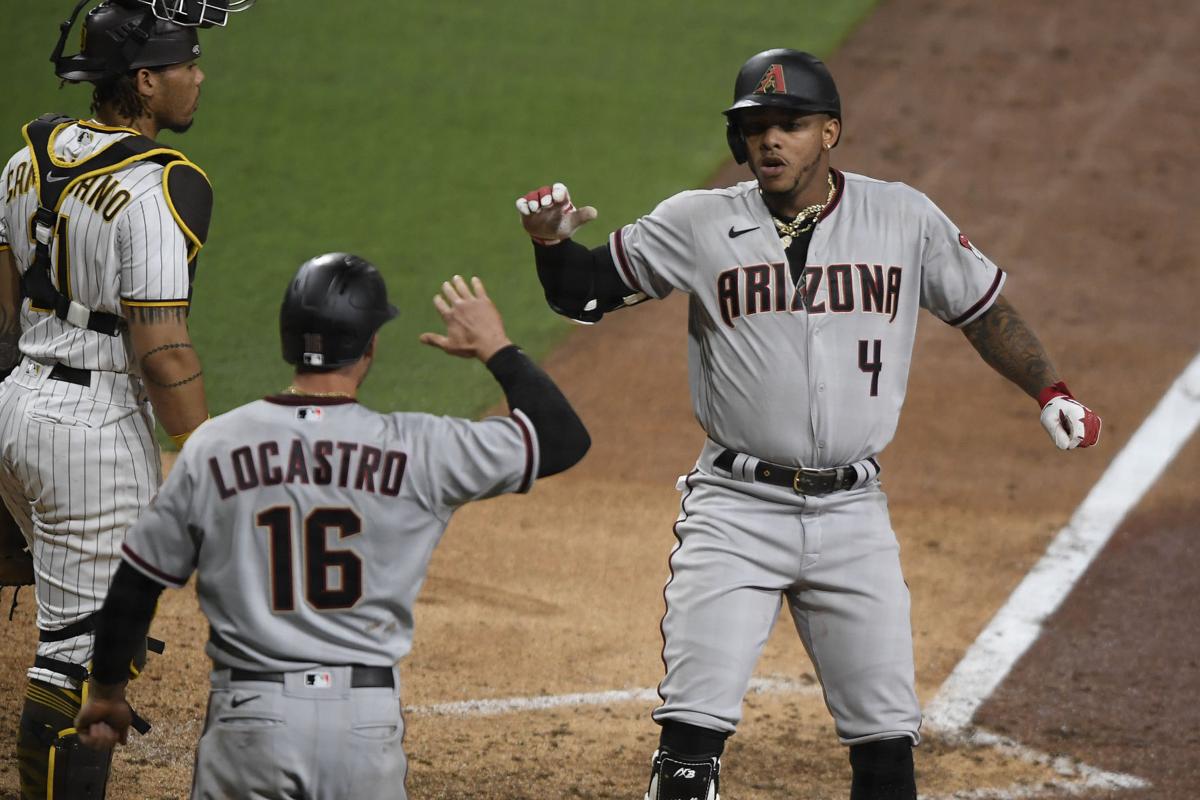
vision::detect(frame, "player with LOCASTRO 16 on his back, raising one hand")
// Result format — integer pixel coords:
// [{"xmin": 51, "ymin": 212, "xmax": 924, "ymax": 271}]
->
[{"xmin": 69, "ymin": 253, "xmax": 590, "ymax": 799}]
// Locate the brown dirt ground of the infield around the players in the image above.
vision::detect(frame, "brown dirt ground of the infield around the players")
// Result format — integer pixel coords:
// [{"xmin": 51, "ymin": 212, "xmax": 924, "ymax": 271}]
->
[{"xmin": 0, "ymin": 0, "xmax": 1200, "ymax": 800}]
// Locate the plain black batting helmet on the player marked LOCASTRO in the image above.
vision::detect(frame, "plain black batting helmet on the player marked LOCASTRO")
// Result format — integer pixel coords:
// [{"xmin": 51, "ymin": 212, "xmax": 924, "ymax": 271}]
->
[{"xmin": 280, "ymin": 253, "xmax": 398, "ymax": 369}]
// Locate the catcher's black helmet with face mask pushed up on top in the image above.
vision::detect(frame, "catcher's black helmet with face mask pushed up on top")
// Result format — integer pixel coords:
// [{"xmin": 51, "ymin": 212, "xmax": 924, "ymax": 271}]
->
[{"xmin": 50, "ymin": 0, "xmax": 254, "ymax": 82}]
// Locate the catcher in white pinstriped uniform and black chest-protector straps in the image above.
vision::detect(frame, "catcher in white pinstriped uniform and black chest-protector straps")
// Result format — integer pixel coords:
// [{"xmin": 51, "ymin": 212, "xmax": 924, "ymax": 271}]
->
[{"xmin": 0, "ymin": 0, "xmax": 250, "ymax": 800}]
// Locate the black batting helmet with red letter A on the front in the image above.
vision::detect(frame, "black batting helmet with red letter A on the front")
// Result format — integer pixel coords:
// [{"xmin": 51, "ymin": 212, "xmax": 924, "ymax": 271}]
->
[{"xmin": 724, "ymin": 48, "xmax": 841, "ymax": 164}]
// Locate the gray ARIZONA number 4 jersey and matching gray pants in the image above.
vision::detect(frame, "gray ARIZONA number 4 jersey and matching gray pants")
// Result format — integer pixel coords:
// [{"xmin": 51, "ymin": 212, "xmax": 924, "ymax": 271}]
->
[{"xmin": 608, "ymin": 172, "xmax": 1004, "ymax": 744}]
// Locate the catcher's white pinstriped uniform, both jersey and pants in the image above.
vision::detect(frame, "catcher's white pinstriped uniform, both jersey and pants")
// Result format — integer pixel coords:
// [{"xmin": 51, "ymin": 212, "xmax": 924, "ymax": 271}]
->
[{"xmin": 0, "ymin": 121, "xmax": 200, "ymax": 686}]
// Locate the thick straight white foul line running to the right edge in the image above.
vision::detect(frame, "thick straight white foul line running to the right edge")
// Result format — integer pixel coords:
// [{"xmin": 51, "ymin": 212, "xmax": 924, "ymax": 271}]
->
[{"xmin": 925, "ymin": 355, "xmax": 1200, "ymax": 734}]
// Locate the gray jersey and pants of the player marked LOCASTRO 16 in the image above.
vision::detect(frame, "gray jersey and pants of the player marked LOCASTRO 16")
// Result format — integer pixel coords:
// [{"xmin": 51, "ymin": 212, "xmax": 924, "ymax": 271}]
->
[{"xmin": 124, "ymin": 396, "xmax": 538, "ymax": 800}]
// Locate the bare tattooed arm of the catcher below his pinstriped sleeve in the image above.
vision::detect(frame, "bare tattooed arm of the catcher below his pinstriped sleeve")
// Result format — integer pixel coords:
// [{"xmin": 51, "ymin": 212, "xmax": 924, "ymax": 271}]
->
[{"xmin": 125, "ymin": 303, "xmax": 209, "ymax": 438}]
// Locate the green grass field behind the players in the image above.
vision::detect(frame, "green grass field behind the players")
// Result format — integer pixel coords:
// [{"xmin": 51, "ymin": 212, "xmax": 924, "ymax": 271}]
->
[{"xmin": 0, "ymin": 0, "xmax": 874, "ymax": 416}]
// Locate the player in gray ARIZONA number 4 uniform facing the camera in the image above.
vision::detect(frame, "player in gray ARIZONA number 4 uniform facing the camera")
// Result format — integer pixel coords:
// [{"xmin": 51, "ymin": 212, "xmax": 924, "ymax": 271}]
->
[{"xmin": 517, "ymin": 49, "xmax": 1100, "ymax": 800}]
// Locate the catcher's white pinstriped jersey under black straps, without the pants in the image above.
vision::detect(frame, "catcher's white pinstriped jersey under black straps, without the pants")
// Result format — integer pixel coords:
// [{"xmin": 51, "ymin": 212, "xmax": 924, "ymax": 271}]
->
[{"xmin": 0, "ymin": 121, "xmax": 198, "ymax": 383}]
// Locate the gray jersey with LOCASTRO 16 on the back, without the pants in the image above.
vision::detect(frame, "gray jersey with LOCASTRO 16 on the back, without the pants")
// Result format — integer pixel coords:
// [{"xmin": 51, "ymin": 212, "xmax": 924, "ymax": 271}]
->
[{"xmin": 124, "ymin": 396, "xmax": 538, "ymax": 670}]
